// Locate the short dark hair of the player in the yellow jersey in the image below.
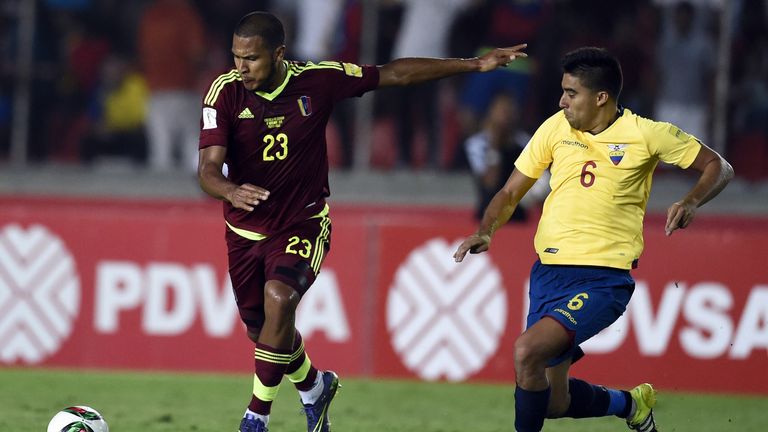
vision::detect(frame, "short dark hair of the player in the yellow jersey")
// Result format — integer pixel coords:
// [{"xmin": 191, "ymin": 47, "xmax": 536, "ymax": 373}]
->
[{"xmin": 561, "ymin": 47, "xmax": 623, "ymax": 100}]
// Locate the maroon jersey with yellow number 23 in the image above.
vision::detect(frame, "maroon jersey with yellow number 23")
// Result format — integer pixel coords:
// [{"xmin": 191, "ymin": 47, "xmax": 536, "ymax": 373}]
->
[{"xmin": 200, "ymin": 62, "xmax": 379, "ymax": 235}]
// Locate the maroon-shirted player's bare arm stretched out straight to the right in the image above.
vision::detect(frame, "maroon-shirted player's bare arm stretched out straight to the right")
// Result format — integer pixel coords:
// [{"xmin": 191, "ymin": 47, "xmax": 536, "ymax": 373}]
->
[{"xmin": 379, "ymin": 44, "xmax": 528, "ymax": 87}]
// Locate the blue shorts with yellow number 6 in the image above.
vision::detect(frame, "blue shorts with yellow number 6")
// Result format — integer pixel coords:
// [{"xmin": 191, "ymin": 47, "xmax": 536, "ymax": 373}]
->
[{"xmin": 526, "ymin": 260, "xmax": 635, "ymax": 366}]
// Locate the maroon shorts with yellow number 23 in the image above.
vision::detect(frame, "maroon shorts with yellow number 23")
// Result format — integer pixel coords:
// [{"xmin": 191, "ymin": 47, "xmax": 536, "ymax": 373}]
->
[{"xmin": 226, "ymin": 216, "xmax": 331, "ymax": 329}]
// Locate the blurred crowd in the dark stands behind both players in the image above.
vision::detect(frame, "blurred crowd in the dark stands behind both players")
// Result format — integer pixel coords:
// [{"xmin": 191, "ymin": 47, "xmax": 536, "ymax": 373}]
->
[{"xmin": 0, "ymin": 0, "xmax": 768, "ymax": 179}]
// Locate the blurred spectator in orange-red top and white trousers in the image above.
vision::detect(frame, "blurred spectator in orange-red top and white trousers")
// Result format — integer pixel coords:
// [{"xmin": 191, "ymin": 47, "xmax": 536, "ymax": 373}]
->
[{"xmin": 138, "ymin": 0, "xmax": 205, "ymax": 172}]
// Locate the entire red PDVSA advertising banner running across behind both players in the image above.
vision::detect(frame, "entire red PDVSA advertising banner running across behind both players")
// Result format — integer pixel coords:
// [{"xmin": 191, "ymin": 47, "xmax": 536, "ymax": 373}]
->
[{"xmin": 0, "ymin": 198, "xmax": 768, "ymax": 394}]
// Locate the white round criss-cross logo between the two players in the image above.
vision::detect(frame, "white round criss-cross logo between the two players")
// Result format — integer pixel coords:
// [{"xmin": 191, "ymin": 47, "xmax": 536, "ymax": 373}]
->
[{"xmin": 386, "ymin": 239, "xmax": 507, "ymax": 381}]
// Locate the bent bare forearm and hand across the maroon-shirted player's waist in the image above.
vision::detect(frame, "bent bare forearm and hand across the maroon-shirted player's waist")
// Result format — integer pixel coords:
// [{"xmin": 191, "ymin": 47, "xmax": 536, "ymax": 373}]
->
[{"xmin": 197, "ymin": 146, "xmax": 269, "ymax": 211}]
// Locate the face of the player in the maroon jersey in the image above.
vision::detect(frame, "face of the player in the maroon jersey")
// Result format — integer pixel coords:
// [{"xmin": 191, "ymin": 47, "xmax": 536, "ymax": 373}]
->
[{"xmin": 232, "ymin": 35, "xmax": 285, "ymax": 91}]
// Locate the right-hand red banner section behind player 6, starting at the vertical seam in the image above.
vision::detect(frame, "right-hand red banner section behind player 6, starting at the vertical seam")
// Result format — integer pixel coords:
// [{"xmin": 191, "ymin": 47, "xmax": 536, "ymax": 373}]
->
[{"xmin": 374, "ymin": 220, "xmax": 768, "ymax": 393}]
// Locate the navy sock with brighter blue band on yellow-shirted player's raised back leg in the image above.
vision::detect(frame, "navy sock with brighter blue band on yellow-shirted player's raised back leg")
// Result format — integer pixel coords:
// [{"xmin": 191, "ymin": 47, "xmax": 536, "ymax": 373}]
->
[{"xmin": 565, "ymin": 378, "xmax": 632, "ymax": 418}]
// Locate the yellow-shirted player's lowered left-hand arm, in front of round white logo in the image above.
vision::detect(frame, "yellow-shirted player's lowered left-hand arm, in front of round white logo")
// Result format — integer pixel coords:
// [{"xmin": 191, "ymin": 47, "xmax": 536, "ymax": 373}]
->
[{"xmin": 453, "ymin": 169, "xmax": 536, "ymax": 262}]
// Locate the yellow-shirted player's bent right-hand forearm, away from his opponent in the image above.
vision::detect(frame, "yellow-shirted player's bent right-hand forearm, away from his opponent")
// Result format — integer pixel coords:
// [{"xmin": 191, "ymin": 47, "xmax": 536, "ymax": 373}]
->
[{"xmin": 664, "ymin": 144, "xmax": 733, "ymax": 236}]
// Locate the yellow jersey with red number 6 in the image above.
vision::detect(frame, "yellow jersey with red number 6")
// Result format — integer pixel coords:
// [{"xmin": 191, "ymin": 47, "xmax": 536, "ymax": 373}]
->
[{"xmin": 515, "ymin": 109, "xmax": 701, "ymax": 269}]
